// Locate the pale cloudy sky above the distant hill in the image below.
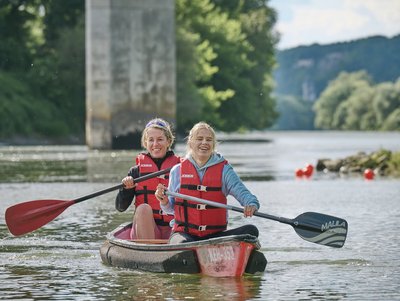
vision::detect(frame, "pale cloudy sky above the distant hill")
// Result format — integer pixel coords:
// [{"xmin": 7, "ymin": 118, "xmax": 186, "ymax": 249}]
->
[{"xmin": 269, "ymin": 0, "xmax": 400, "ymax": 50}]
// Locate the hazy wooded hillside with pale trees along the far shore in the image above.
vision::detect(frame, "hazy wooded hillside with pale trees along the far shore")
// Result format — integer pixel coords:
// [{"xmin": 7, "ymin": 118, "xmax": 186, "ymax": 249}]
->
[{"xmin": 274, "ymin": 35, "xmax": 400, "ymax": 131}]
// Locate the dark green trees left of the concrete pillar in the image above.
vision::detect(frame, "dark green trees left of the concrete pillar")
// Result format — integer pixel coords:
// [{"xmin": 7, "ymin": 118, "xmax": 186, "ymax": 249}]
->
[{"xmin": 0, "ymin": 0, "xmax": 85, "ymax": 141}]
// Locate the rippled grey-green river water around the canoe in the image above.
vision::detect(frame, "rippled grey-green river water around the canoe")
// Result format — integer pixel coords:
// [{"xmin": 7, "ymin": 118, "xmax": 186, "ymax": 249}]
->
[{"xmin": 0, "ymin": 132, "xmax": 400, "ymax": 300}]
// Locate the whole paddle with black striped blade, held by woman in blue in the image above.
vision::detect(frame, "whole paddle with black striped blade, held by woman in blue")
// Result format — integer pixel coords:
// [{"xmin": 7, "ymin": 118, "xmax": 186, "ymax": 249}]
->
[{"xmin": 165, "ymin": 191, "xmax": 348, "ymax": 248}]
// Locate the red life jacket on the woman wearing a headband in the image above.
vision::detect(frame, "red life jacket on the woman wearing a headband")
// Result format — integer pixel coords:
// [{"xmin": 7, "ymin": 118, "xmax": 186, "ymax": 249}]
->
[{"xmin": 135, "ymin": 153, "xmax": 180, "ymax": 226}]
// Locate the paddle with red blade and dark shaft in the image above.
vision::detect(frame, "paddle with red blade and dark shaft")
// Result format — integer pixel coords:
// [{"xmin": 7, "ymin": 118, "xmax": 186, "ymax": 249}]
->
[{"xmin": 5, "ymin": 168, "xmax": 171, "ymax": 236}]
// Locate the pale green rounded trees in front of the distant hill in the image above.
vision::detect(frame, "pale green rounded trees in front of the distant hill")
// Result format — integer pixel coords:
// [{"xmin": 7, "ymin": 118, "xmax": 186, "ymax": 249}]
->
[{"xmin": 314, "ymin": 71, "xmax": 400, "ymax": 131}]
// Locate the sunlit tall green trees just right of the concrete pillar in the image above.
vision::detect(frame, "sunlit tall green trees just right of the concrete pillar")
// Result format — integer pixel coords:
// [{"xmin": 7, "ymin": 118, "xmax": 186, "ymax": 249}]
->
[{"xmin": 176, "ymin": 0, "xmax": 277, "ymax": 131}]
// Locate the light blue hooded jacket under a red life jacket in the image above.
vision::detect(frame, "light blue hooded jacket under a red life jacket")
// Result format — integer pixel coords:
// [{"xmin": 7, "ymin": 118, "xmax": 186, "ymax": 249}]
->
[{"xmin": 161, "ymin": 153, "xmax": 260, "ymax": 214}]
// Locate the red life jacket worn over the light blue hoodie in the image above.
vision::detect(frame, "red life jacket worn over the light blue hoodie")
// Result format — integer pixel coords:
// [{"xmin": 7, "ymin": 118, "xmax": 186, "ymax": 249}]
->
[{"xmin": 173, "ymin": 159, "xmax": 228, "ymax": 237}]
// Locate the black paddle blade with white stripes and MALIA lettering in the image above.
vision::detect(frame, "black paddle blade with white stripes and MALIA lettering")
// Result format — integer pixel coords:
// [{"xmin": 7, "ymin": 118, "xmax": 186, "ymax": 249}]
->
[{"xmin": 292, "ymin": 212, "xmax": 348, "ymax": 248}]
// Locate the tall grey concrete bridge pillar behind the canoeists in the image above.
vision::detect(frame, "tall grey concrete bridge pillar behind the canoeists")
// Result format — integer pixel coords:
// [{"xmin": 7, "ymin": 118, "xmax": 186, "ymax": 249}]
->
[{"xmin": 86, "ymin": 0, "xmax": 176, "ymax": 149}]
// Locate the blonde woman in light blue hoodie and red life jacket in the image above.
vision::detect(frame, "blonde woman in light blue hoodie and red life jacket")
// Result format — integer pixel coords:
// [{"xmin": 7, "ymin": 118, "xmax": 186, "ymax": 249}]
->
[{"xmin": 156, "ymin": 122, "xmax": 260, "ymax": 243}]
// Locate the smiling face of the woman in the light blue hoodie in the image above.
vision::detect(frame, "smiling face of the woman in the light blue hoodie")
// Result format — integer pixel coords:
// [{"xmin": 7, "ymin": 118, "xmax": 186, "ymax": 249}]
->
[{"xmin": 189, "ymin": 128, "xmax": 215, "ymax": 162}]
